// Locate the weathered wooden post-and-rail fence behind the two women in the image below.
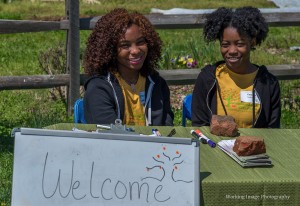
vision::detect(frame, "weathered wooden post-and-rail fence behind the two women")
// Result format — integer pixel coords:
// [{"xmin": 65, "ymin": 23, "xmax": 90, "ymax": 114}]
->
[{"xmin": 0, "ymin": 0, "xmax": 300, "ymax": 114}]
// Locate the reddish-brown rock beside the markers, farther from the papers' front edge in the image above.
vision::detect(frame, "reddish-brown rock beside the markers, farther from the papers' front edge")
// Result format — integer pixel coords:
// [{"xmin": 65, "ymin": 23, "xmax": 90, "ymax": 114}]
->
[{"xmin": 210, "ymin": 115, "xmax": 238, "ymax": 137}]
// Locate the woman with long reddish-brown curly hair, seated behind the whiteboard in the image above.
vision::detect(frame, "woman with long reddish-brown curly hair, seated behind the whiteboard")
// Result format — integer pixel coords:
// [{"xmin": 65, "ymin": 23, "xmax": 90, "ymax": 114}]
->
[{"xmin": 84, "ymin": 8, "xmax": 174, "ymax": 125}]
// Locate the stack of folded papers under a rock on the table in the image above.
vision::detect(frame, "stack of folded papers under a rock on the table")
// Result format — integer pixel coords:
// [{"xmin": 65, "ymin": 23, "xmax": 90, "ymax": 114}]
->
[{"xmin": 218, "ymin": 139, "xmax": 273, "ymax": 167}]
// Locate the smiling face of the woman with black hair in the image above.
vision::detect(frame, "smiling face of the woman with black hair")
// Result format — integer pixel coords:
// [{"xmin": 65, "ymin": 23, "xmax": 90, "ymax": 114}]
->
[{"xmin": 220, "ymin": 27, "xmax": 255, "ymax": 74}]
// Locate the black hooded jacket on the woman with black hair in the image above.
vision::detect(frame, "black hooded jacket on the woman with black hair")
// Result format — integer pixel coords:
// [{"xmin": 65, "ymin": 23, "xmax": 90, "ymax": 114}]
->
[{"xmin": 192, "ymin": 61, "xmax": 281, "ymax": 128}]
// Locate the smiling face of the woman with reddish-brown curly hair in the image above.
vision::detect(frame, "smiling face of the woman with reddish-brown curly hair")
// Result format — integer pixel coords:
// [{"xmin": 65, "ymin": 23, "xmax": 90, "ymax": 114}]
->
[{"xmin": 117, "ymin": 24, "xmax": 148, "ymax": 73}]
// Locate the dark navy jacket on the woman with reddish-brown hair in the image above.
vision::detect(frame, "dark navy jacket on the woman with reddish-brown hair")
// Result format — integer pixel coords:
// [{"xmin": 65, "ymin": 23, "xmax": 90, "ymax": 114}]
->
[{"xmin": 84, "ymin": 74, "xmax": 174, "ymax": 126}]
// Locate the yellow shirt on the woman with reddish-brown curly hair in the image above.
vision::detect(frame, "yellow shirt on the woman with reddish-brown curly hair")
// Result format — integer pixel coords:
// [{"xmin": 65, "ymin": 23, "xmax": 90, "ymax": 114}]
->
[{"xmin": 115, "ymin": 73, "xmax": 146, "ymax": 126}]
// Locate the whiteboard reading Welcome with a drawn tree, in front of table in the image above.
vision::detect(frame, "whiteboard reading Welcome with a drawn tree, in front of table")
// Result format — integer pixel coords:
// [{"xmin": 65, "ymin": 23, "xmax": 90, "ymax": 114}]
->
[{"xmin": 12, "ymin": 128, "xmax": 200, "ymax": 206}]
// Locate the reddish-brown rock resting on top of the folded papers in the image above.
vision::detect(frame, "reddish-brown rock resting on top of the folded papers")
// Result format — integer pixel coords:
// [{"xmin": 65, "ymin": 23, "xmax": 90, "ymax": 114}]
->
[{"xmin": 233, "ymin": 136, "xmax": 266, "ymax": 156}]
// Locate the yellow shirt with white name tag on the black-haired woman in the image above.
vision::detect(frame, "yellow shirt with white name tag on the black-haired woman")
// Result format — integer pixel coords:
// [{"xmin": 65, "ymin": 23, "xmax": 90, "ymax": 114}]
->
[{"xmin": 216, "ymin": 64, "xmax": 260, "ymax": 128}]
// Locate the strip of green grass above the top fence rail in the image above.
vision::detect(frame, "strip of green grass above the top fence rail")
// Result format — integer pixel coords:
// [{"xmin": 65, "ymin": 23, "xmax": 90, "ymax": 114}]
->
[{"xmin": 0, "ymin": 0, "xmax": 275, "ymax": 20}]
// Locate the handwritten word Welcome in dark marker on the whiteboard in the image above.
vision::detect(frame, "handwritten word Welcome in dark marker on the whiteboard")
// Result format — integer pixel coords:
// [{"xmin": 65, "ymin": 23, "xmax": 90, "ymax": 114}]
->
[{"xmin": 41, "ymin": 152, "xmax": 171, "ymax": 202}]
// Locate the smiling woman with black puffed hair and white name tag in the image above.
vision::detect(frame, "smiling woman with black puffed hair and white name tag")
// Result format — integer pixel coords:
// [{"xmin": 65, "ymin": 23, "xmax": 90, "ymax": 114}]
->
[{"xmin": 192, "ymin": 7, "xmax": 281, "ymax": 128}]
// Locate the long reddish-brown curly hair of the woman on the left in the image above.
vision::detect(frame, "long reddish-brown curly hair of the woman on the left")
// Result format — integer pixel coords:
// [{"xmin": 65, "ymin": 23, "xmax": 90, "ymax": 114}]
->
[{"xmin": 84, "ymin": 8, "xmax": 162, "ymax": 76}]
